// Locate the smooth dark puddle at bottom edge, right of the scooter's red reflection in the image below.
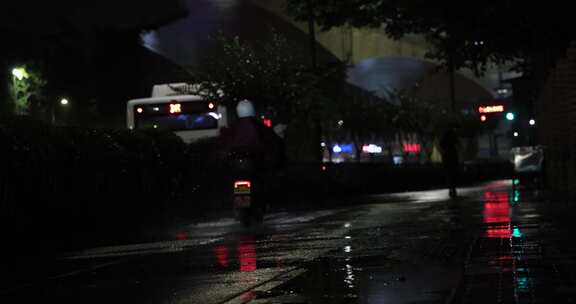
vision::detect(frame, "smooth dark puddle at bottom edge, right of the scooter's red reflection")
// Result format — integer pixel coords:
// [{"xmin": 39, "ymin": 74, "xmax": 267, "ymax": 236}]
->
[{"xmin": 255, "ymin": 256, "xmax": 460, "ymax": 303}]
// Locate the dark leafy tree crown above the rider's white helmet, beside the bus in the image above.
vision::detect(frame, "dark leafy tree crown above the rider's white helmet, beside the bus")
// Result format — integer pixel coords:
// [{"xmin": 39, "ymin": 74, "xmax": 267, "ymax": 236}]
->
[{"xmin": 187, "ymin": 32, "xmax": 343, "ymax": 123}]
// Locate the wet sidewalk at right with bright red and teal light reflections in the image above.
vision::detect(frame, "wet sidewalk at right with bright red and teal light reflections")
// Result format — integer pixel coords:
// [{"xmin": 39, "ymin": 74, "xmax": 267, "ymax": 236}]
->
[{"xmin": 451, "ymin": 185, "xmax": 576, "ymax": 303}]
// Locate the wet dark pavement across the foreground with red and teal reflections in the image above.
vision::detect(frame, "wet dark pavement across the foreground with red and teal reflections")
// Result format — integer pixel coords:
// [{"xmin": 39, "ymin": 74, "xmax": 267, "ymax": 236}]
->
[{"xmin": 0, "ymin": 181, "xmax": 576, "ymax": 303}]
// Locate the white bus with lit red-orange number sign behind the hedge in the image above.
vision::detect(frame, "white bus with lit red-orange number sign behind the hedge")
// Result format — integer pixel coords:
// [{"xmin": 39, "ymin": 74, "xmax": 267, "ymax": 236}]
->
[{"xmin": 126, "ymin": 84, "xmax": 228, "ymax": 143}]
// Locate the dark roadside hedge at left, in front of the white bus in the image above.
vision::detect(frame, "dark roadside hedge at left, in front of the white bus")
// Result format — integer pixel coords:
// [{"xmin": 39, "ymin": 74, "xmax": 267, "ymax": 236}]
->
[{"xmin": 0, "ymin": 117, "xmax": 198, "ymax": 251}]
